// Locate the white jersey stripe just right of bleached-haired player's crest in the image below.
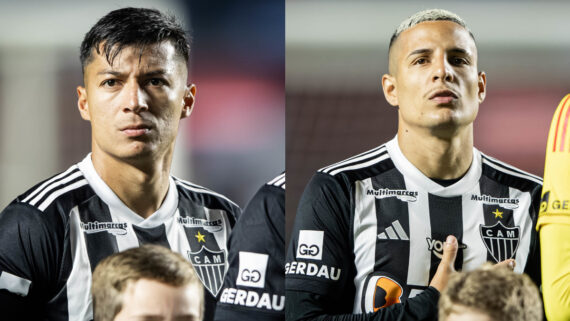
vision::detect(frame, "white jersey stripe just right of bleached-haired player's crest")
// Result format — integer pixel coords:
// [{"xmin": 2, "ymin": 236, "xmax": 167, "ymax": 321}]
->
[{"xmin": 509, "ymin": 187, "xmax": 533, "ymax": 273}]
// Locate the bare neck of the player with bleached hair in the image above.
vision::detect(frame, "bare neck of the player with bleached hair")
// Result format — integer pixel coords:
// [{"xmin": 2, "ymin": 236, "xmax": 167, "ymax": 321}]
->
[{"xmin": 398, "ymin": 125, "xmax": 473, "ymax": 179}]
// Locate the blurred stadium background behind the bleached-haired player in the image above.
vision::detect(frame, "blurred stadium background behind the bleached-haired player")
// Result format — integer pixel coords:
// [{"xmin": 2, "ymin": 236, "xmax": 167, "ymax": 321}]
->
[{"xmin": 285, "ymin": 0, "xmax": 570, "ymax": 235}]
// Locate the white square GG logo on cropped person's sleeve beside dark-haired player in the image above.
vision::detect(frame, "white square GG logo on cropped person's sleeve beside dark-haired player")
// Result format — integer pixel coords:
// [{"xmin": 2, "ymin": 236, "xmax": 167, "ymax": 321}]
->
[{"xmin": 236, "ymin": 251, "xmax": 269, "ymax": 288}]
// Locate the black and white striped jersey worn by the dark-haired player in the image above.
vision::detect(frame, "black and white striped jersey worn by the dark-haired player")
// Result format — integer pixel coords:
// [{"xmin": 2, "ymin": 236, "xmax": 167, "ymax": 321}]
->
[{"xmin": 0, "ymin": 155, "xmax": 240, "ymax": 321}]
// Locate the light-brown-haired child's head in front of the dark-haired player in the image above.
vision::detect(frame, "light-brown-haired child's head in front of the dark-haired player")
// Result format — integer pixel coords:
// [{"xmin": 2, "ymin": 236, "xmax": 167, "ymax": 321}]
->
[{"xmin": 91, "ymin": 245, "xmax": 204, "ymax": 321}]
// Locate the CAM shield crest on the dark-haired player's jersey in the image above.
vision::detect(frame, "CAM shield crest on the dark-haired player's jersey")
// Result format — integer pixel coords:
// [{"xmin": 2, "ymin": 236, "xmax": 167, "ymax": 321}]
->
[{"xmin": 188, "ymin": 246, "xmax": 226, "ymax": 296}]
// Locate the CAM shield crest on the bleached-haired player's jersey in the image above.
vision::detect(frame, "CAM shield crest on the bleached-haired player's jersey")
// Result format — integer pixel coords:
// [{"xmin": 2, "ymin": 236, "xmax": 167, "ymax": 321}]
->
[{"xmin": 479, "ymin": 221, "xmax": 520, "ymax": 263}]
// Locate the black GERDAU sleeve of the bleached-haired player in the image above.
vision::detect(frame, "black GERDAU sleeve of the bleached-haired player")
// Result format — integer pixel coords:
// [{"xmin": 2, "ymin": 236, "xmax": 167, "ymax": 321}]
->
[{"xmin": 285, "ymin": 173, "xmax": 355, "ymax": 304}]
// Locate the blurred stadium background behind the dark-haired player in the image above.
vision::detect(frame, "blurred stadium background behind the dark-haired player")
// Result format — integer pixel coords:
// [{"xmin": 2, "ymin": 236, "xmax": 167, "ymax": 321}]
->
[{"xmin": 0, "ymin": 0, "xmax": 285, "ymax": 208}]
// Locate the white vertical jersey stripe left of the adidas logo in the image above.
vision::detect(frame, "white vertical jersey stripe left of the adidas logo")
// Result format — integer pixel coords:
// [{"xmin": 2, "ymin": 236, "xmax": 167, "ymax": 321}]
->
[{"xmin": 343, "ymin": 178, "xmax": 378, "ymax": 313}]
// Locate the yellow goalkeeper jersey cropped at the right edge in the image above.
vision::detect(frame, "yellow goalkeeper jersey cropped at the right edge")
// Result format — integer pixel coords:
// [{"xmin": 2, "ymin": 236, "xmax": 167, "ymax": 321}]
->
[{"xmin": 536, "ymin": 94, "xmax": 570, "ymax": 321}]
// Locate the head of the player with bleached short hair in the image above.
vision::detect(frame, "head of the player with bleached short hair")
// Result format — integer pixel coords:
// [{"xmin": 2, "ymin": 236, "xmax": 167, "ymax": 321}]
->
[{"xmin": 382, "ymin": 9, "xmax": 486, "ymax": 137}]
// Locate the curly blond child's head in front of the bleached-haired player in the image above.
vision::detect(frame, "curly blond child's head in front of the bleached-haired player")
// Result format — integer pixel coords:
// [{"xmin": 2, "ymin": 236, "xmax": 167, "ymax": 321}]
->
[{"xmin": 439, "ymin": 265, "xmax": 543, "ymax": 321}]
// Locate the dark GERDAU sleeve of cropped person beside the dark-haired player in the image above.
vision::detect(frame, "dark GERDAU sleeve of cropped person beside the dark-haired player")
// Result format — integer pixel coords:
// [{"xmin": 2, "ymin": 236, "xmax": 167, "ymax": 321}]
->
[{"xmin": 215, "ymin": 173, "xmax": 285, "ymax": 321}]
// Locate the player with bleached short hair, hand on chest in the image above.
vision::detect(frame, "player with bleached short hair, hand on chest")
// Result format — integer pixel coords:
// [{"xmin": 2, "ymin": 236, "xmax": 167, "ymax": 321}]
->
[{"xmin": 285, "ymin": 9, "xmax": 542, "ymax": 321}]
